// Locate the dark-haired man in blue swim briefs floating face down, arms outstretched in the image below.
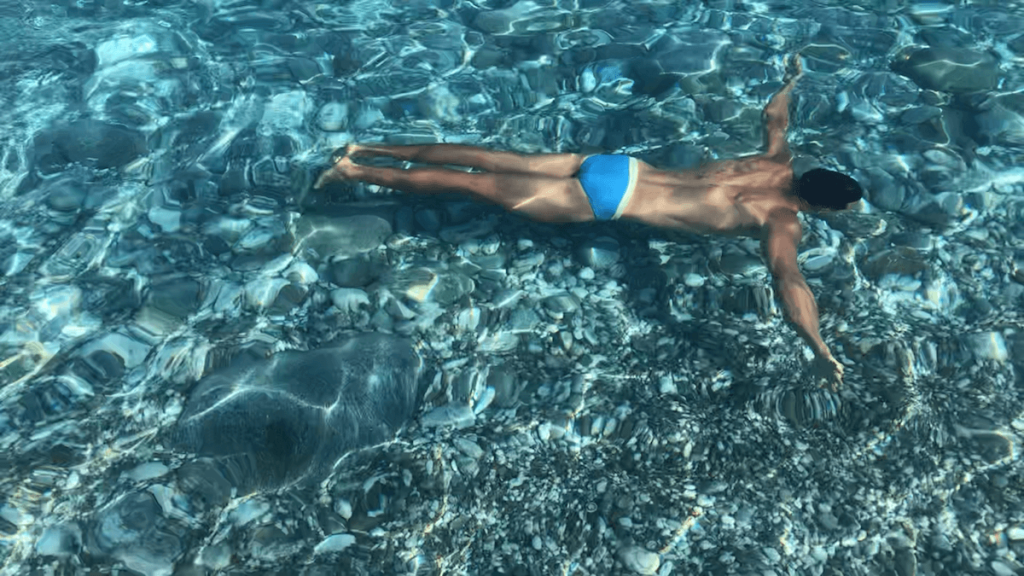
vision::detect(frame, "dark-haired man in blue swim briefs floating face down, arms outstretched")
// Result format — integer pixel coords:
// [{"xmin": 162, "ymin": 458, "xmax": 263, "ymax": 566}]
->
[{"xmin": 315, "ymin": 56, "xmax": 861, "ymax": 389}]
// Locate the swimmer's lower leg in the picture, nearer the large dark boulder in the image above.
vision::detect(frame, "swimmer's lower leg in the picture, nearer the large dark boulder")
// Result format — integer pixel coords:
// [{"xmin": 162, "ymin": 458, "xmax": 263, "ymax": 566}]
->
[{"xmin": 314, "ymin": 157, "xmax": 594, "ymax": 222}]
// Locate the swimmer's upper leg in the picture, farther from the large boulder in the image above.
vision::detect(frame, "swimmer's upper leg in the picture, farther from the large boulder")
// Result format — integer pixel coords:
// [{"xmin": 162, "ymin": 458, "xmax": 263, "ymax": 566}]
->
[{"xmin": 347, "ymin": 143, "xmax": 585, "ymax": 178}]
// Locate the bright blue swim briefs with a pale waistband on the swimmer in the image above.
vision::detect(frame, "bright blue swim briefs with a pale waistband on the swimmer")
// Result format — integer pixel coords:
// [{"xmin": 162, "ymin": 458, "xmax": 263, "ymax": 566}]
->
[{"xmin": 579, "ymin": 154, "xmax": 638, "ymax": 220}]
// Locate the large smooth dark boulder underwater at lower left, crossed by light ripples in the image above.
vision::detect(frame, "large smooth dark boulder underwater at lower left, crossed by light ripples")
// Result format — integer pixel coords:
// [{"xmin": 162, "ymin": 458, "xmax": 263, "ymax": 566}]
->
[{"xmin": 172, "ymin": 334, "xmax": 422, "ymax": 492}]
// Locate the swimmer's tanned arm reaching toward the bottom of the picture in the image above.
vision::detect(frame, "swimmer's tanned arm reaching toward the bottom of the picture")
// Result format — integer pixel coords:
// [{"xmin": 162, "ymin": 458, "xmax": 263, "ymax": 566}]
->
[{"xmin": 761, "ymin": 214, "xmax": 843, "ymax": 389}]
